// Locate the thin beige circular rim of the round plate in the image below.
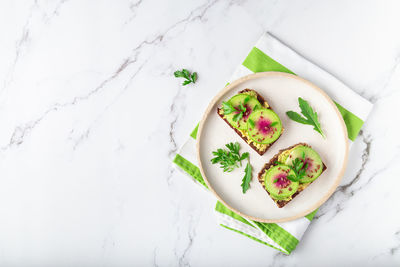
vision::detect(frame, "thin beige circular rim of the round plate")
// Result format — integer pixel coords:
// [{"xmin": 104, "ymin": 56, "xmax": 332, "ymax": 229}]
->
[{"xmin": 196, "ymin": 71, "xmax": 349, "ymax": 223}]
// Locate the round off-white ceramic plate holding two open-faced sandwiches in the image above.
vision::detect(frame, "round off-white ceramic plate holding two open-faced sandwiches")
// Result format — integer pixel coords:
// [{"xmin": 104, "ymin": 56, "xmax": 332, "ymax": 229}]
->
[{"xmin": 197, "ymin": 72, "xmax": 348, "ymax": 222}]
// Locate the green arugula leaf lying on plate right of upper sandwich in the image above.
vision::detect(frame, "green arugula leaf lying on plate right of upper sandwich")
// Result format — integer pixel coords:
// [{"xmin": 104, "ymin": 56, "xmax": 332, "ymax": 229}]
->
[{"xmin": 286, "ymin": 97, "xmax": 325, "ymax": 138}]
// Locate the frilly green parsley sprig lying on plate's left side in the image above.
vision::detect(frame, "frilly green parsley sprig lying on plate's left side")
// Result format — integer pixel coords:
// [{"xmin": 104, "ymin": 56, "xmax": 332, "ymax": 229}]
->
[{"xmin": 211, "ymin": 142, "xmax": 249, "ymax": 172}]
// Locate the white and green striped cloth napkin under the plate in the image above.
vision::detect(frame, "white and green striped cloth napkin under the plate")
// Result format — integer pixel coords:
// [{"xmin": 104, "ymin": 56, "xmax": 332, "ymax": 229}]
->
[{"xmin": 174, "ymin": 33, "xmax": 372, "ymax": 254}]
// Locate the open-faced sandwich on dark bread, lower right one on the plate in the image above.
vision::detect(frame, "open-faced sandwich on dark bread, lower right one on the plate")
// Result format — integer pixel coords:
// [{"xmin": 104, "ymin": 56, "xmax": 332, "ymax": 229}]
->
[{"xmin": 258, "ymin": 143, "xmax": 326, "ymax": 208}]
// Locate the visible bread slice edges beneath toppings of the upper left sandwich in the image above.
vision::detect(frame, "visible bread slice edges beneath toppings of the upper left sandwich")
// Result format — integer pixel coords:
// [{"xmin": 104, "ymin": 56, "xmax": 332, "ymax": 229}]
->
[{"xmin": 217, "ymin": 89, "xmax": 284, "ymax": 156}]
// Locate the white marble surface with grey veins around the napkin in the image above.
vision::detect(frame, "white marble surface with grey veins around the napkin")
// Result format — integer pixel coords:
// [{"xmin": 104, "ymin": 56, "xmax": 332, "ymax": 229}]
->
[{"xmin": 0, "ymin": 0, "xmax": 400, "ymax": 266}]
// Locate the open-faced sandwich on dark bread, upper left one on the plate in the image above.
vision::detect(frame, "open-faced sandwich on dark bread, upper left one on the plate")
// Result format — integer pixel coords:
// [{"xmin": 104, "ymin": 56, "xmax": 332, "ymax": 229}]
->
[{"xmin": 217, "ymin": 89, "xmax": 283, "ymax": 155}]
